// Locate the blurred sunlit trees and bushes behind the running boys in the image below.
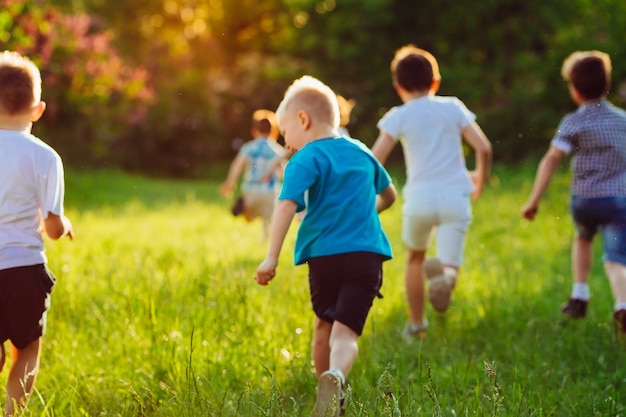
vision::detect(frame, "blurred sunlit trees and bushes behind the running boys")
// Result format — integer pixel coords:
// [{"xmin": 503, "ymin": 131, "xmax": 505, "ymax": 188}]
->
[{"xmin": 0, "ymin": 0, "xmax": 626, "ymax": 178}]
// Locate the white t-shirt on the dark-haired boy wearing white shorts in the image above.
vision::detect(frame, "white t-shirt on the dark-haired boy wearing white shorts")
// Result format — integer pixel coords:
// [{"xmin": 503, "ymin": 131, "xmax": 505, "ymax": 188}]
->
[{"xmin": 378, "ymin": 96, "xmax": 476, "ymax": 212}]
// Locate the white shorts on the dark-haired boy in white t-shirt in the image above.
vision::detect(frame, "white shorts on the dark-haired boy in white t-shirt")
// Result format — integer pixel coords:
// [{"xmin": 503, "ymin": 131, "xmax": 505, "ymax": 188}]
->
[{"xmin": 402, "ymin": 192, "xmax": 472, "ymax": 267}]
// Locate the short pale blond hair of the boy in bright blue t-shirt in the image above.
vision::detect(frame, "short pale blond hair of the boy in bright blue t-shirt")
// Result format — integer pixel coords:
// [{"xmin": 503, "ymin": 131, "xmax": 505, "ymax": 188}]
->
[{"xmin": 276, "ymin": 75, "xmax": 339, "ymax": 128}]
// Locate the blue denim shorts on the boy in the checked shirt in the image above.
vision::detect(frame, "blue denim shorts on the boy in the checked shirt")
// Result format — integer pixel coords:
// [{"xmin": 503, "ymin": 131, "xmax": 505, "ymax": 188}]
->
[{"xmin": 570, "ymin": 196, "xmax": 626, "ymax": 265}]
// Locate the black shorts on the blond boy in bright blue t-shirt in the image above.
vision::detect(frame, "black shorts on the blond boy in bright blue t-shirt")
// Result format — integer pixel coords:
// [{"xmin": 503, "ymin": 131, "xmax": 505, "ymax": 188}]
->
[{"xmin": 308, "ymin": 252, "xmax": 386, "ymax": 335}]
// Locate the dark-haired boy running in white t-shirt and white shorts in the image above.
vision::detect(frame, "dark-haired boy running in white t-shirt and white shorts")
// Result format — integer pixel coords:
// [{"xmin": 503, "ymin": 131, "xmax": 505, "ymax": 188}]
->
[{"xmin": 372, "ymin": 45, "xmax": 492, "ymax": 337}]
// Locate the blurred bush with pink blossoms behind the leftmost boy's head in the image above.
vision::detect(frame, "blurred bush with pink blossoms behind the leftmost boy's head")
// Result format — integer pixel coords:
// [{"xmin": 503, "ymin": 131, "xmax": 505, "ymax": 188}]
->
[{"xmin": 0, "ymin": 0, "xmax": 152, "ymax": 165}]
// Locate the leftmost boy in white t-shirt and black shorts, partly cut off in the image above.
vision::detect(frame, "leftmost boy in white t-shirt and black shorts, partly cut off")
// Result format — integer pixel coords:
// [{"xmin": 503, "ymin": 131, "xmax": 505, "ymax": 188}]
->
[{"xmin": 0, "ymin": 51, "xmax": 73, "ymax": 416}]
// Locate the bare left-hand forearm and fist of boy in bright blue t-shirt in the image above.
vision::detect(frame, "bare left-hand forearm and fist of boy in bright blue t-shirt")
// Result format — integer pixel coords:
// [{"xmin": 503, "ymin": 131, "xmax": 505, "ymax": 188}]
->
[{"xmin": 254, "ymin": 200, "xmax": 298, "ymax": 285}]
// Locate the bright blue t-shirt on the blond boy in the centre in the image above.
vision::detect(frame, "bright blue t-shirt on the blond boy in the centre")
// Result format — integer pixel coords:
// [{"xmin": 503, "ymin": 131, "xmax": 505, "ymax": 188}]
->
[{"xmin": 278, "ymin": 138, "xmax": 392, "ymax": 265}]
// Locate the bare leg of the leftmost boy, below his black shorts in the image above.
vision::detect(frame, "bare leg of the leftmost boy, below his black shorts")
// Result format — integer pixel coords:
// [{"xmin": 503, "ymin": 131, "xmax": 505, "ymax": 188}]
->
[{"xmin": 5, "ymin": 338, "xmax": 41, "ymax": 416}]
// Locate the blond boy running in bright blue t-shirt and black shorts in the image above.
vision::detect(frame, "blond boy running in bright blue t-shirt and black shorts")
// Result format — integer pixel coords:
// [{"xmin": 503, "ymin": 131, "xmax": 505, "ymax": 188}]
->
[{"xmin": 255, "ymin": 76, "xmax": 396, "ymax": 416}]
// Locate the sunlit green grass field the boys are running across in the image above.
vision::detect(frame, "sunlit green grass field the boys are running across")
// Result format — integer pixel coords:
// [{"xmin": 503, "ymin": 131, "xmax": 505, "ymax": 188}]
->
[{"xmin": 2, "ymin": 164, "xmax": 626, "ymax": 417}]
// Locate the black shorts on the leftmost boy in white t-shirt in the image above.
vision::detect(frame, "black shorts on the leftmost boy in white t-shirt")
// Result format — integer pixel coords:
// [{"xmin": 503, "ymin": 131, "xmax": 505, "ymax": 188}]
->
[{"xmin": 0, "ymin": 264, "xmax": 55, "ymax": 349}]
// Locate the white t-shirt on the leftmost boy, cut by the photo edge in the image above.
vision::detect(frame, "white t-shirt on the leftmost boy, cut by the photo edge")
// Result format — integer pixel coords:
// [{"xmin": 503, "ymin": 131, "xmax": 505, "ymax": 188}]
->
[{"xmin": 0, "ymin": 130, "xmax": 65, "ymax": 269}]
